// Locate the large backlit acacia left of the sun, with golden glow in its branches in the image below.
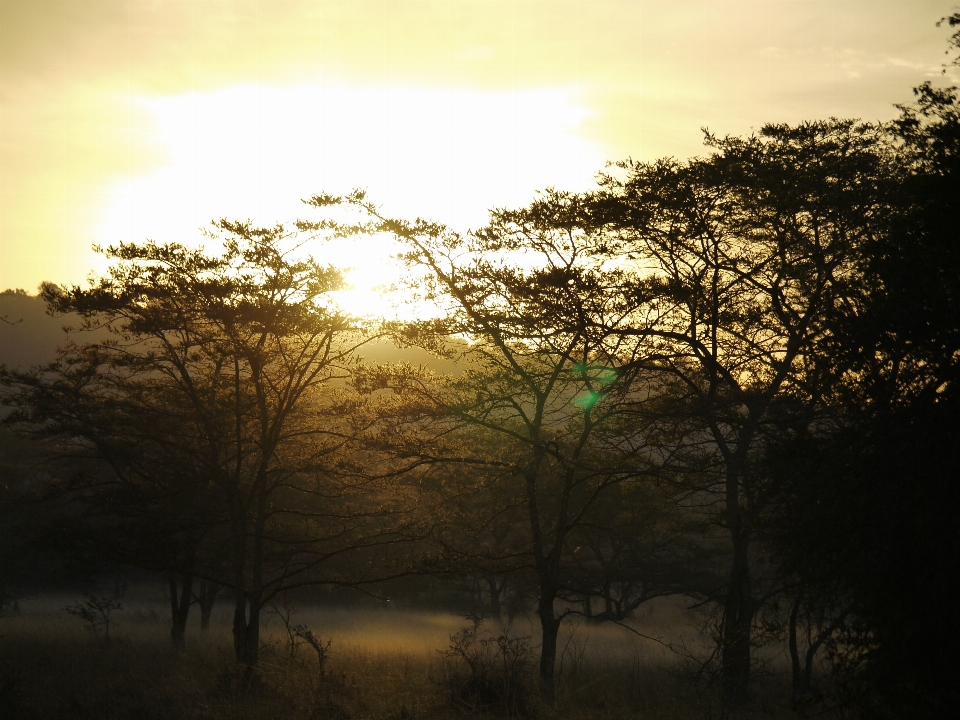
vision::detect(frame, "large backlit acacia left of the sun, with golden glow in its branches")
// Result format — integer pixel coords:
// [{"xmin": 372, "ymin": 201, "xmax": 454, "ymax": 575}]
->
[{"xmin": 20, "ymin": 221, "xmax": 396, "ymax": 666}]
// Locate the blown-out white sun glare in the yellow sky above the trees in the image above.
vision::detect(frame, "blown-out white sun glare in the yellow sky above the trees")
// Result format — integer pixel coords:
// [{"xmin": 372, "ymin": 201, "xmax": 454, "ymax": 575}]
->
[{"xmin": 97, "ymin": 85, "xmax": 604, "ymax": 314}]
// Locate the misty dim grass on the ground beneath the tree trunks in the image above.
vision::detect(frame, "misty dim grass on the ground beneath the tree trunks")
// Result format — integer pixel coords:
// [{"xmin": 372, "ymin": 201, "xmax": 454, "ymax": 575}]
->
[{"xmin": 0, "ymin": 598, "xmax": 792, "ymax": 720}]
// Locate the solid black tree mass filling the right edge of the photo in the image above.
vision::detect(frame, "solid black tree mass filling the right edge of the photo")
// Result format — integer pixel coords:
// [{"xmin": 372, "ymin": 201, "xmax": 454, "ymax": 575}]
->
[{"xmin": 767, "ymin": 84, "xmax": 960, "ymax": 717}]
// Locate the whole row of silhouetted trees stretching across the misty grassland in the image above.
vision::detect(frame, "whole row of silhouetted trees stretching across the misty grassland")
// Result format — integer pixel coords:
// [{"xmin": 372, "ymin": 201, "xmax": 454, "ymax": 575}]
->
[{"xmin": 0, "ymin": 29, "xmax": 960, "ymax": 717}]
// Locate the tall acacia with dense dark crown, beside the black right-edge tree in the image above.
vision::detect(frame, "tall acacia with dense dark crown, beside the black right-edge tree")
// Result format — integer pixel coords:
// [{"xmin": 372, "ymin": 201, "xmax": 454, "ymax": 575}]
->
[{"xmin": 592, "ymin": 120, "xmax": 886, "ymax": 706}]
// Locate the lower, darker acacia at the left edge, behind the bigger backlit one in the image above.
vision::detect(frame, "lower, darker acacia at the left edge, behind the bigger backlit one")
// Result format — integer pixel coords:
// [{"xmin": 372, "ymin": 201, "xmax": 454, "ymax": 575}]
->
[{"xmin": 0, "ymin": 343, "xmax": 217, "ymax": 650}]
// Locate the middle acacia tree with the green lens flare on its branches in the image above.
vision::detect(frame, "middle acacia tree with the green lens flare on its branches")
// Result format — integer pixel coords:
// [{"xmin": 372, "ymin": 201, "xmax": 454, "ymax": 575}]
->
[{"xmin": 311, "ymin": 193, "xmax": 676, "ymax": 698}]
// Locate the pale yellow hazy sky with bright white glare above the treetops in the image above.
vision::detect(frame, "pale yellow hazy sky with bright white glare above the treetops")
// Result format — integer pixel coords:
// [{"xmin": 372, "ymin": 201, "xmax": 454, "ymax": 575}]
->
[{"xmin": 0, "ymin": 0, "xmax": 960, "ymax": 314}]
